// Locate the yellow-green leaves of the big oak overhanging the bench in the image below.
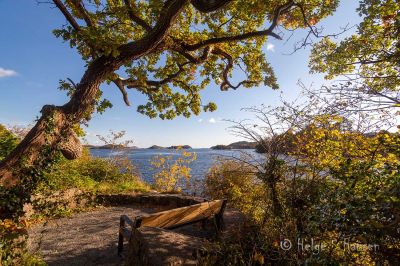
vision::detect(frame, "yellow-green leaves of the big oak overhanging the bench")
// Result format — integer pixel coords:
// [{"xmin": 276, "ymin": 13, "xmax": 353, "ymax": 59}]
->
[{"xmin": 50, "ymin": 0, "xmax": 339, "ymax": 119}]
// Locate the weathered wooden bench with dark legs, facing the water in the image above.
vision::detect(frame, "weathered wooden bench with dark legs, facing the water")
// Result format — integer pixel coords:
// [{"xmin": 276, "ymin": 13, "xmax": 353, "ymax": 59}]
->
[{"xmin": 118, "ymin": 200, "xmax": 226, "ymax": 255}]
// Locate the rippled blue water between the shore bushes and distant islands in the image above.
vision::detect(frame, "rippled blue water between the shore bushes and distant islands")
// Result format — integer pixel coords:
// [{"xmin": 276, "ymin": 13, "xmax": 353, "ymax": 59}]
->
[{"xmin": 90, "ymin": 149, "xmax": 255, "ymax": 183}]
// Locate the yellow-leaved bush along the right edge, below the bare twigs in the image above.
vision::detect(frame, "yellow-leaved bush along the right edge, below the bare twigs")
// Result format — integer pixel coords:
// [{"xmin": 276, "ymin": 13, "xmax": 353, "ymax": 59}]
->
[{"xmin": 291, "ymin": 118, "xmax": 400, "ymax": 260}]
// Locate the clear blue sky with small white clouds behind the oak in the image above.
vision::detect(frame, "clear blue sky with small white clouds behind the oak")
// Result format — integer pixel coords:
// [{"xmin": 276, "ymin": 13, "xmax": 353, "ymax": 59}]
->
[{"xmin": 0, "ymin": 0, "xmax": 359, "ymax": 147}]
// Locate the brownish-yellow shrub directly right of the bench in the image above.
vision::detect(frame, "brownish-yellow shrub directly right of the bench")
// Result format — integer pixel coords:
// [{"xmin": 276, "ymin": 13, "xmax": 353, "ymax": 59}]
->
[{"xmin": 205, "ymin": 157, "xmax": 319, "ymax": 265}]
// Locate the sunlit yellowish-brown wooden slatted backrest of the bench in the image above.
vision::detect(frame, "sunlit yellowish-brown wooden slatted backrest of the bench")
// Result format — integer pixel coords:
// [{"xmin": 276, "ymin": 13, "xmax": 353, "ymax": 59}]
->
[{"xmin": 134, "ymin": 200, "xmax": 226, "ymax": 229}]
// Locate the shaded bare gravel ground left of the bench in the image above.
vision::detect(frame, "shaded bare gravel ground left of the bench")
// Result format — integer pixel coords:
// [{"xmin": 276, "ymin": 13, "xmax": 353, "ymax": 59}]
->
[{"xmin": 29, "ymin": 207, "xmax": 151, "ymax": 266}]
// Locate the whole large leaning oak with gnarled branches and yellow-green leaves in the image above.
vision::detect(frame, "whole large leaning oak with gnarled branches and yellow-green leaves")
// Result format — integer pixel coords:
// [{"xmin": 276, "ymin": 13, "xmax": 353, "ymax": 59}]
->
[{"xmin": 0, "ymin": 0, "xmax": 338, "ymax": 187}]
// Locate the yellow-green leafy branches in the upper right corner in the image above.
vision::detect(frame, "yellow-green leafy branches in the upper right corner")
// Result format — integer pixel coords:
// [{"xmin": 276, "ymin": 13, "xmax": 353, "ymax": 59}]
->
[{"xmin": 310, "ymin": 0, "xmax": 400, "ymax": 92}]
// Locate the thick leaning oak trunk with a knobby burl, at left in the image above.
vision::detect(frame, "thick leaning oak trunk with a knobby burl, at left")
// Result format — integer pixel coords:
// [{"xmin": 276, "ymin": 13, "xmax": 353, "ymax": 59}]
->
[{"xmin": 0, "ymin": 60, "xmax": 106, "ymax": 187}]
